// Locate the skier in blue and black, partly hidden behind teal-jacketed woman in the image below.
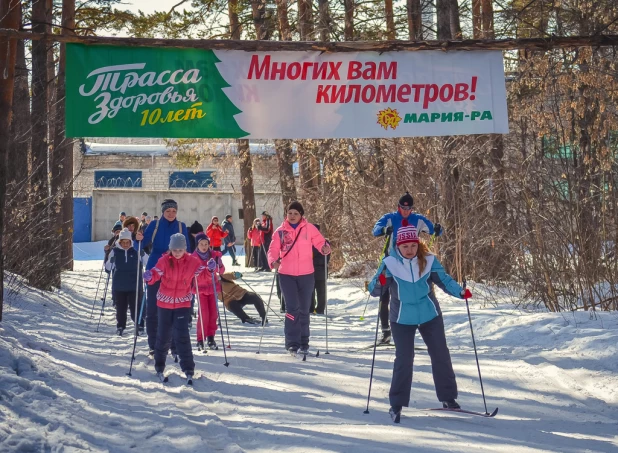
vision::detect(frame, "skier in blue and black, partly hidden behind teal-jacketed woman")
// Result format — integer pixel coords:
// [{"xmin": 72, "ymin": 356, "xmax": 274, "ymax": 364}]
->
[{"xmin": 373, "ymin": 192, "xmax": 442, "ymax": 343}]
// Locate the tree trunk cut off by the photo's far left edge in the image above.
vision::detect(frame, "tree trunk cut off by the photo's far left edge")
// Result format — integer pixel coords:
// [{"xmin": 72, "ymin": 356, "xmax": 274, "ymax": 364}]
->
[{"xmin": 0, "ymin": 0, "xmax": 21, "ymax": 321}]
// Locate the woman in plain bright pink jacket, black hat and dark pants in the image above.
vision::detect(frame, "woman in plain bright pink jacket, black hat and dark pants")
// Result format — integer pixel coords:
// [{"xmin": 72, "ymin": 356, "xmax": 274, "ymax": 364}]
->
[{"xmin": 268, "ymin": 201, "xmax": 330, "ymax": 355}]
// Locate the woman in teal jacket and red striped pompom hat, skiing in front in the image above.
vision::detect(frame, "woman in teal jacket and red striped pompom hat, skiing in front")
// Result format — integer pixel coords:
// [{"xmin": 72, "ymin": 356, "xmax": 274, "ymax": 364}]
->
[{"xmin": 369, "ymin": 225, "xmax": 472, "ymax": 423}]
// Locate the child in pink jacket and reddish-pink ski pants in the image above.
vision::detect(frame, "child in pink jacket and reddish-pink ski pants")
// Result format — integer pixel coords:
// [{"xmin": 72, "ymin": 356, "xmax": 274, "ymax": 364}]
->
[{"xmin": 193, "ymin": 233, "xmax": 225, "ymax": 351}]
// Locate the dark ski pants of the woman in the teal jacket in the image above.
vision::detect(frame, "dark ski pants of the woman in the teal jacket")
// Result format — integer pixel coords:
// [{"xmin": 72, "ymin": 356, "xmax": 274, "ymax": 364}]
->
[{"xmin": 388, "ymin": 315, "xmax": 457, "ymax": 407}]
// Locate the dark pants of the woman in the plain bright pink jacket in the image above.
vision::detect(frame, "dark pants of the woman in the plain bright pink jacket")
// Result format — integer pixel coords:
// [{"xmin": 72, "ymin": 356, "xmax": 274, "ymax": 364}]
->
[{"xmin": 279, "ymin": 274, "xmax": 315, "ymax": 350}]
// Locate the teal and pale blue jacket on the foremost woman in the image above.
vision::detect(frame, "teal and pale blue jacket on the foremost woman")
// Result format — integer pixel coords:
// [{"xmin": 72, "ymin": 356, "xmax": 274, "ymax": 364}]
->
[{"xmin": 369, "ymin": 250, "xmax": 463, "ymax": 325}]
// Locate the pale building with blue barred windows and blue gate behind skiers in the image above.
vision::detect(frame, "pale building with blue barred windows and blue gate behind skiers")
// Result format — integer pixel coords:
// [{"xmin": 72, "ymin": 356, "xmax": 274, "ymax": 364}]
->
[{"xmin": 73, "ymin": 139, "xmax": 283, "ymax": 242}]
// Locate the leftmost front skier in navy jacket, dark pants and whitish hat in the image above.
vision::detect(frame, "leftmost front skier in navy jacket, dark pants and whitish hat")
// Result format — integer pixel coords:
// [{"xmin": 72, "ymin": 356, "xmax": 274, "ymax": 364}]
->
[{"xmin": 105, "ymin": 228, "xmax": 144, "ymax": 336}]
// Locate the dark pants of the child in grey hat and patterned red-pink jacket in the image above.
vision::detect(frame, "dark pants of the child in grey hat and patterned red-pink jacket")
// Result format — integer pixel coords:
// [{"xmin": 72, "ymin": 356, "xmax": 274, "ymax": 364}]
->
[{"xmin": 154, "ymin": 307, "xmax": 195, "ymax": 374}]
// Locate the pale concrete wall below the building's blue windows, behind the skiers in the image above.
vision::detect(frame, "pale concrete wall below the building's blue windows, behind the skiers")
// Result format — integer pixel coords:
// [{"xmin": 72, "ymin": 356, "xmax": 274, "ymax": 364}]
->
[{"xmin": 92, "ymin": 189, "xmax": 283, "ymax": 241}]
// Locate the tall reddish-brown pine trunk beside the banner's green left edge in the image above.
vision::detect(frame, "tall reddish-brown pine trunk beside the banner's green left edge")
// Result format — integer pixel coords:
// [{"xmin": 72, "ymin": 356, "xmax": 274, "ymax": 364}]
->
[{"xmin": 52, "ymin": 0, "xmax": 75, "ymax": 270}]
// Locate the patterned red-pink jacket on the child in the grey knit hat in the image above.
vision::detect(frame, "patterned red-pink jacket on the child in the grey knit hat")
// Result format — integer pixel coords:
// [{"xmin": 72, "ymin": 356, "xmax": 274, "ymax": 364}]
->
[{"xmin": 148, "ymin": 253, "xmax": 207, "ymax": 309}]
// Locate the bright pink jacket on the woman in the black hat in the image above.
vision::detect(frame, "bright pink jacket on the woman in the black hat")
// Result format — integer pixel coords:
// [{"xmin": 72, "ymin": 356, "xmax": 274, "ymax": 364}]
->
[{"xmin": 268, "ymin": 218, "xmax": 326, "ymax": 276}]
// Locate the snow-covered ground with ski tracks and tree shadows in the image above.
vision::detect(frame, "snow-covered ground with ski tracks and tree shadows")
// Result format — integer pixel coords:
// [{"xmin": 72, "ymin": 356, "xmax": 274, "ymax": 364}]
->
[{"xmin": 0, "ymin": 243, "xmax": 618, "ymax": 453}]
